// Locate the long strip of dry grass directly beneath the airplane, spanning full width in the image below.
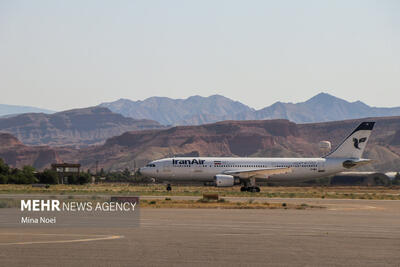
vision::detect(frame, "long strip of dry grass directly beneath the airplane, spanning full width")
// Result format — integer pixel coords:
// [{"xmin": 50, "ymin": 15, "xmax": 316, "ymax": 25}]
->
[{"xmin": 0, "ymin": 183, "xmax": 400, "ymax": 200}]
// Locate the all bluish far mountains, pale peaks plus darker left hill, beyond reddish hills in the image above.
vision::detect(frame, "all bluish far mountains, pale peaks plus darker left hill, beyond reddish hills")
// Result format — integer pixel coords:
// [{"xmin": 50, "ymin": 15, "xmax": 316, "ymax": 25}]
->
[{"xmin": 0, "ymin": 93, "xmax": 400, "ymax": 147}]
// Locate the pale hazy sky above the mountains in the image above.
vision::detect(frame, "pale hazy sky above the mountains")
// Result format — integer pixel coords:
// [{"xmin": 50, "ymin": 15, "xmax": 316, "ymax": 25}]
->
[{"xmin": 0, "ymin": 0, "xmax": 400, "ymax": 110}]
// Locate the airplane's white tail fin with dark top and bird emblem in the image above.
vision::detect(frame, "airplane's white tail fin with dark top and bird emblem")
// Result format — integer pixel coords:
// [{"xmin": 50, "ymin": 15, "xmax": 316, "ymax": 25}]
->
[{"xmin": 324, "ymin": 121, "xmax": 375, "ymax": 159}]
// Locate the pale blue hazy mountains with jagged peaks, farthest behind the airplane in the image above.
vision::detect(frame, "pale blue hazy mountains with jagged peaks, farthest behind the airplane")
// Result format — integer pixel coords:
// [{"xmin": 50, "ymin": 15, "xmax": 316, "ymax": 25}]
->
[{"xmin": 100, "ymin": 93, "xmax": 400, "ymax": 125}]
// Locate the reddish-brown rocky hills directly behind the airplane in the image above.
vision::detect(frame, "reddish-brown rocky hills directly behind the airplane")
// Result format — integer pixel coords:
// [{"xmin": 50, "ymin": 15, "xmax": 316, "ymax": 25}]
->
[{"xmin": 0, "ymin": 117, "xmax": 400, "ymax": 171}]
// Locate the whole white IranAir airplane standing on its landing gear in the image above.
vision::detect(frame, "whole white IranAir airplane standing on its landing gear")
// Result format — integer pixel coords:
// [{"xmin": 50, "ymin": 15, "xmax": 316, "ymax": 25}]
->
[{"xmin": 139, "ymin": 122, "xmax": 375, "ymax": 192}]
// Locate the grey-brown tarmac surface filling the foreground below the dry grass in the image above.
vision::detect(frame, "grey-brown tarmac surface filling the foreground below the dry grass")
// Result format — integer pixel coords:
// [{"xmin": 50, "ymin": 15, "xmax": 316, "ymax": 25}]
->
[{"xmin": 0, "ymin": 197, "xmax": 400, "ymax": 266}]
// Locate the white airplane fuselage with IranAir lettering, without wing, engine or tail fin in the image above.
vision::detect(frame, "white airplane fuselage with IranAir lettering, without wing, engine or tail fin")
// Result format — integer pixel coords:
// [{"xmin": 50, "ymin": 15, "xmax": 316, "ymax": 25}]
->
[{"xmin": 140, "ymin": 157, "xmax": 352, "ymax": 182}]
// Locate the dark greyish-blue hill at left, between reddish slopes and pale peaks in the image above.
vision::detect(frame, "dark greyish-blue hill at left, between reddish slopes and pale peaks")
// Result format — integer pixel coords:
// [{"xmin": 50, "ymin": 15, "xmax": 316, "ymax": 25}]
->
[{"xmin": 0, "ymin": 107, "xmax": 162, "ymax": 147}]
